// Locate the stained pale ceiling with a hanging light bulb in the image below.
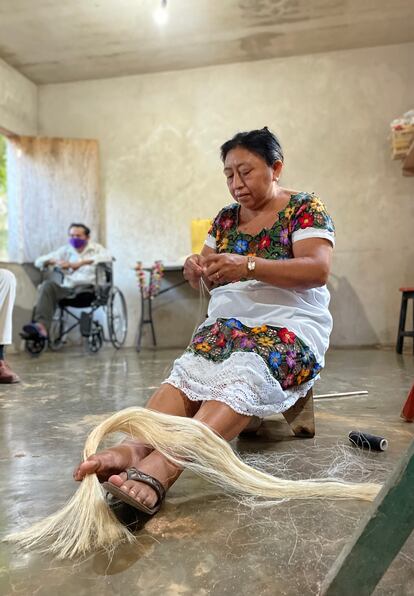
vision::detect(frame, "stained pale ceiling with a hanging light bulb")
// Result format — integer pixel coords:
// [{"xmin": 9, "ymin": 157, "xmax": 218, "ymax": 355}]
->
[{"xmin": 0, "ymin": 0, "xmax": 414, "ymax": 84}]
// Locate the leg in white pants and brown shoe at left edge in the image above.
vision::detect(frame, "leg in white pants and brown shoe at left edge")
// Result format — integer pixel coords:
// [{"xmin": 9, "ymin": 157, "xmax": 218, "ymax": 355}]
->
[{"xmin": 0, "ymin": 269, "xmax": 20, "ymax": 383}]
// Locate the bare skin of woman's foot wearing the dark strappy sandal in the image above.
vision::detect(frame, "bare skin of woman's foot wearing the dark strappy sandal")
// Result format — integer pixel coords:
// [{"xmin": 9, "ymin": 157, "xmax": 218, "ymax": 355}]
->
[{"xmin": 108, "ymin": 451, "xmax": 182, "ymax": 507}]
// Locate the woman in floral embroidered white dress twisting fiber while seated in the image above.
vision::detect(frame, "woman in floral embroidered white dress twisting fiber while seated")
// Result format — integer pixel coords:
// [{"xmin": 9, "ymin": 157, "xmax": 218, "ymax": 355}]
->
[{"xmin": 74, "ymin": 127, "xmax": 334, "ymax": 514}]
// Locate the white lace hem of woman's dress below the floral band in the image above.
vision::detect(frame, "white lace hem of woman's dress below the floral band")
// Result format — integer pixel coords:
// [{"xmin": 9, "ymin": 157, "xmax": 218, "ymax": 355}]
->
[{"xmin": 164, "ymin": 352, "xmax": 319, "ymax": 418}]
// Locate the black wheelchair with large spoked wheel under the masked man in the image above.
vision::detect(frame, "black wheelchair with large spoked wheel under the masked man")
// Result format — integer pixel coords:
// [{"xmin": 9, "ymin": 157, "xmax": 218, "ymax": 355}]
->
[{"xmin": 22, "ymin": 263, "xmax": 128, "ymax": 356}]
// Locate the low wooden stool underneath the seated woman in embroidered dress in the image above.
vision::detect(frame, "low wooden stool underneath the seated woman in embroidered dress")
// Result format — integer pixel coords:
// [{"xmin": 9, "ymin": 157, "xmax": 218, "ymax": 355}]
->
[{"xmin": 239, "ymin": 388, "xmax": 315, "ymax": 439}]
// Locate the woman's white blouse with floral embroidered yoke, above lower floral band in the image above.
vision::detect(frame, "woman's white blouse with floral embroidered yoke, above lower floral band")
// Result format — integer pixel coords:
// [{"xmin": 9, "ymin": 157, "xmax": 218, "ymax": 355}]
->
[{"xmin": 199, "ymin": 192, "xmax": 335, "ymax": 366}]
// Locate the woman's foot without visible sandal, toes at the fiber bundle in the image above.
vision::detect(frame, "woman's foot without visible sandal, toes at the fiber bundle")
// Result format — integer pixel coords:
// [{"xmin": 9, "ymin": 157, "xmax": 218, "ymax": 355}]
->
[{"xmin": 73, "ymin": 440, "xmax": 152, "ymax": 482}]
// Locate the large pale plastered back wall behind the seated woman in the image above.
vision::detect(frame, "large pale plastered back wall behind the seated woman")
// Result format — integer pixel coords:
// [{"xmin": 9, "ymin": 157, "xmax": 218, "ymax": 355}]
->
[{"xmin": 39, "ymin": 44, "xmax": 414, "ymax": 345}]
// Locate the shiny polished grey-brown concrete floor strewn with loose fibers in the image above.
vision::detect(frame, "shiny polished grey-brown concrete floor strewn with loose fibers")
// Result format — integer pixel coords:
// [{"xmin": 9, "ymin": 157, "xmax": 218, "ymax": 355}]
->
[{"xmin": 0, "ymin": 348, "xmax": 414, "ymax": 596}]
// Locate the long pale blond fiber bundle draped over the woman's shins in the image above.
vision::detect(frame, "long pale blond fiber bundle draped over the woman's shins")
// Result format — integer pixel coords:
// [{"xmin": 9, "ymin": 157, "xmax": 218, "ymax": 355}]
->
[{"xmin": 6, "ymin": 408, "xmax": 381, "ymax": 559}]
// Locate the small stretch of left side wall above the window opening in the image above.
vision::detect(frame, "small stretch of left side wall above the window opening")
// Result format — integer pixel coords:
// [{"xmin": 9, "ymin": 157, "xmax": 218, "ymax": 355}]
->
[{"xmin": 0, "ymin": 60, "xmax": 37, "ymax": 135}]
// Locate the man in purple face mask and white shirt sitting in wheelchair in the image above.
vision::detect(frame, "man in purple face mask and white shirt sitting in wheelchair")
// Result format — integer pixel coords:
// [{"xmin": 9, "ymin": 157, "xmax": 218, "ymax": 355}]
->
[{"xmin": 22, "ymin": 223, "xmax": 112, "ymax": 340}]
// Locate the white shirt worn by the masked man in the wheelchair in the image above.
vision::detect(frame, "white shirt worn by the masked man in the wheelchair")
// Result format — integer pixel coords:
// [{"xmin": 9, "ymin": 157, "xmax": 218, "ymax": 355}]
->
[{"xmin": 35, "ymin": 241, "xmax": 112, "ymax": 288}]
